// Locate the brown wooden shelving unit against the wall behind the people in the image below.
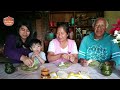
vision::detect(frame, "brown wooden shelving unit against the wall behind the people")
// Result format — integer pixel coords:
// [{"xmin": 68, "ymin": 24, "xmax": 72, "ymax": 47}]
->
[{"xmin": 49, "ymin": 11, "xmax": 104, "ymax": 46}]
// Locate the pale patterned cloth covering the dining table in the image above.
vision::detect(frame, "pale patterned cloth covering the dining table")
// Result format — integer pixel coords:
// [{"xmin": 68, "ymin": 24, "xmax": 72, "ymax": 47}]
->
[{"xmin": 0, "ymin": 63, "xmax": 120, "ymax": 79}]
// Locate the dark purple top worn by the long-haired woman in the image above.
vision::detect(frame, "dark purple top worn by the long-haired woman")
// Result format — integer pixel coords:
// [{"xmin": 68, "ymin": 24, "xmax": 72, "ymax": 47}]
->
[{"xmin": 4, "ymin": 35, "xmax": 31, "ymax": 62}]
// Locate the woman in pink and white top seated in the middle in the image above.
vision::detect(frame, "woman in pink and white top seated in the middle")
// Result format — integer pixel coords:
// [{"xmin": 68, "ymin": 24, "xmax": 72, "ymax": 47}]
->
[{"xmin": 47, "ymin": 24, "xmax": 78, "ymax": 64}]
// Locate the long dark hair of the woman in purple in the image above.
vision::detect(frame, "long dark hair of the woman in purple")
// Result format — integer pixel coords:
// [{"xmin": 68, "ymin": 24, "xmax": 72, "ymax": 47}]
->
[{"xmin": 16, "ymin": 20, "xmax": 36, "ymax": 48}]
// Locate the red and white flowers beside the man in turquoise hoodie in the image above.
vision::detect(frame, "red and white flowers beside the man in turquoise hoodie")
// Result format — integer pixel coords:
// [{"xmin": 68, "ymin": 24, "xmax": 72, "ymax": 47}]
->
[{"xmin": 110, "ymin": 19, "xmax": 120, "ymax": 47}]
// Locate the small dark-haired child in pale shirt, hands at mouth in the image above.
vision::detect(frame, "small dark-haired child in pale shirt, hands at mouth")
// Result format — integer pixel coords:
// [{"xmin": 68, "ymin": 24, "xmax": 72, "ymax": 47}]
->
[{"xmin": 29, "ymin": 39, "xmax": 46, "ymax": 67}]
